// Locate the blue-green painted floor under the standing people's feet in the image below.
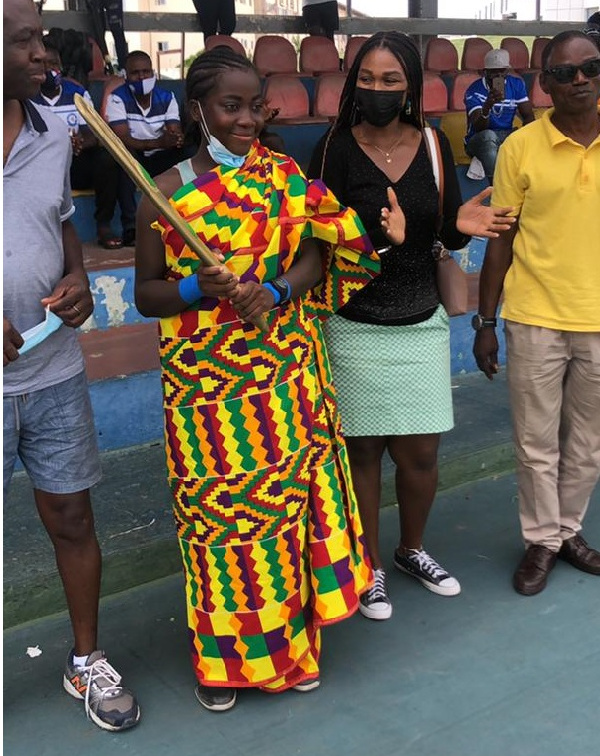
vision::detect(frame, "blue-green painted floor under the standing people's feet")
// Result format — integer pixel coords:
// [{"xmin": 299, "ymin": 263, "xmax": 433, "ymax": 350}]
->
[{"xmin": 4, "ymin": 475, "xmax": 600, "ymax": 756}]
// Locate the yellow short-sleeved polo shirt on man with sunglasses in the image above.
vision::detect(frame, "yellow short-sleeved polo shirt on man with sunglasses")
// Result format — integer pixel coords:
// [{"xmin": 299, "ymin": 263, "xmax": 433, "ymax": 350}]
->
[{"xmin": 492, "ymin": 109, "xmax": 600, "ymax": 331}]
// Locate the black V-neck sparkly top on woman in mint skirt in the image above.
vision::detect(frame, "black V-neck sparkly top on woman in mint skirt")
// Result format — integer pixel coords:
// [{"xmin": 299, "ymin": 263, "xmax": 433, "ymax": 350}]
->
[{"xmin": 308, "ymin": 130, "xmax": 469, "ymax": 325}]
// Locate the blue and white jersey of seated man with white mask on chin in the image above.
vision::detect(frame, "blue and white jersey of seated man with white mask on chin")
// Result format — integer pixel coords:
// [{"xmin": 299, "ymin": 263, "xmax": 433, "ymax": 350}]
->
[{"xmin": 106, "ymin": 84, "xmax": 179, "ymax": 156}]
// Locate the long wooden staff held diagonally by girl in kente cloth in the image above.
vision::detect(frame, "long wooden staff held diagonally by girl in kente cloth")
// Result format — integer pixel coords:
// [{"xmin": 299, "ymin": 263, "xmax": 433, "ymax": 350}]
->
[{"xmin": 73, "ymin": 94, "xmax": 269, "ymax": 333}]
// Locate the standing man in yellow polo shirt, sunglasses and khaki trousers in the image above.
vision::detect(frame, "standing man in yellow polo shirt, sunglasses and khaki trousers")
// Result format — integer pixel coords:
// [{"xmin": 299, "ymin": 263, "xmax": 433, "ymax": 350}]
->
[{"xmin": 473, "ymin": 31, "xmax": 600, "ymax": 596}]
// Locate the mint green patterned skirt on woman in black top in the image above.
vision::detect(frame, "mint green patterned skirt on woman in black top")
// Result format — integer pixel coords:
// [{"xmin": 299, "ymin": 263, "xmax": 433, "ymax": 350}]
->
[{"xmin": 323, "ymin": 305, "xmax": 454, "ymax": 436}]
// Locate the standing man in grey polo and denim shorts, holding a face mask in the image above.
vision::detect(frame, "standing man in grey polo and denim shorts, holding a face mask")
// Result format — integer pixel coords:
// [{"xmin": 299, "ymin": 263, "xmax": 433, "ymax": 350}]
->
[{"xmin": 3, "ymin": 0, "xmax": 140, "ymax": 732}]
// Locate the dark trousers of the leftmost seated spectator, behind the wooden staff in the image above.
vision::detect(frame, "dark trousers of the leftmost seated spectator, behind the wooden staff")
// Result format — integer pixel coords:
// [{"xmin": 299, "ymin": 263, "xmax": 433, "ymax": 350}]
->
[{"xmin": 71, "ymin": 147, "xmax": 119, "ymax": 228}]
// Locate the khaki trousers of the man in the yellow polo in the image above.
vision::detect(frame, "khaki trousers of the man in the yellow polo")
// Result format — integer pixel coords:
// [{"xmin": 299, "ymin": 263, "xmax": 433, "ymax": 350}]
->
[{"xmin": 506, "ymin": 321, "xmax": 600, "ymax": 551}]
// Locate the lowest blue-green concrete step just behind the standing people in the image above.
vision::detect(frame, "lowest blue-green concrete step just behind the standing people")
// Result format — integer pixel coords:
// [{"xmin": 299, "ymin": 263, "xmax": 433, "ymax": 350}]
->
[{"xmin": 4, "ymin": 375, "xmax": 513, "ymax": 627}]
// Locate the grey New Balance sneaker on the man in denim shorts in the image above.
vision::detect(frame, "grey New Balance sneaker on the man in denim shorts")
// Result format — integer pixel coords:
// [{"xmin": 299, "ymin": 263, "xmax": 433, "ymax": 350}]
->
[{"xmin": 63, "ymin": 649, "xmax": 140, "ymax": 732}]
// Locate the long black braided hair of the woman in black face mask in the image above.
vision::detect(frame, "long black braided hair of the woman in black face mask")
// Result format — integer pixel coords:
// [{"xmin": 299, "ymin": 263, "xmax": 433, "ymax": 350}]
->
[{"xmin": 332, "ymin": 31, "xmax": 424, "ymax": 132}]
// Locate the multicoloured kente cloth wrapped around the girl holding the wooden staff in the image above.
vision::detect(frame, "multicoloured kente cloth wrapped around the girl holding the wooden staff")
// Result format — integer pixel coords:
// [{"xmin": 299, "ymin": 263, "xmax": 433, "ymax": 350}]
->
[{"xmin": 155, "ymin": 144, "xmax": 379, "ymax": 690}]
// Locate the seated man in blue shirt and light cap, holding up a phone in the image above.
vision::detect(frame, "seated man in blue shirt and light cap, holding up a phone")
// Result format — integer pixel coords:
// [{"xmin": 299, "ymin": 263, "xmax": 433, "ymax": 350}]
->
[{"xmin": 465, "ymin": 50, "xmax": 535, "ymax": 183}]
